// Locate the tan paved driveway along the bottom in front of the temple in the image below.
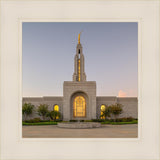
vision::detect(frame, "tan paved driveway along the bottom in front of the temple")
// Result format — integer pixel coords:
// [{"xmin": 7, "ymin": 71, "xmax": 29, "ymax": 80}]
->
[{"xmin": 22, "ymin": 124, "xmax": 138, "ymax": 138}]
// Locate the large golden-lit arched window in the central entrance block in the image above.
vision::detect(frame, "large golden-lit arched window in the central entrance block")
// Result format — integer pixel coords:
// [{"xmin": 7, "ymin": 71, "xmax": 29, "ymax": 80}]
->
[{"xmin": 73, "ymin": 96, "xmax": 86, "ymax": 117}]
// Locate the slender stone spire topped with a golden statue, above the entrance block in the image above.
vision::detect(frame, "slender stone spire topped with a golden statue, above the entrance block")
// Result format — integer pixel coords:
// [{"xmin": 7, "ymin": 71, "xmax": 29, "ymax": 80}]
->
[{"xmin": 73, "ymin": 33, "xmax": 86, "ymax": 82}]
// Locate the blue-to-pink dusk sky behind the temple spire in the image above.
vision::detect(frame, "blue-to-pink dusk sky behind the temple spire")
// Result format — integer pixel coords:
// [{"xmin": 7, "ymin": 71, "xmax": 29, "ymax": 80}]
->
[{"xmin": 22, "ymin": 22, "xmax": 138, "ymax": 97}]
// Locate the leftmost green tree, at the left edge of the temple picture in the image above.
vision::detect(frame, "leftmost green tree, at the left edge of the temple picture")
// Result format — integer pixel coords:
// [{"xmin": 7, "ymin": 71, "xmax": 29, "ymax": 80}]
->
[{"xmin": 22, "ymin": 103, "xmax": 34, "ymax": 120}]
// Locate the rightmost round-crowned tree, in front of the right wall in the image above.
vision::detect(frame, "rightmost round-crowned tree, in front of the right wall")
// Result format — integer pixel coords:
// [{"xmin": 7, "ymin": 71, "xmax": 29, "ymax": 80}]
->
[{"xmin": 111, "ymin": 103, "xmax": 123, "ymax": 121}]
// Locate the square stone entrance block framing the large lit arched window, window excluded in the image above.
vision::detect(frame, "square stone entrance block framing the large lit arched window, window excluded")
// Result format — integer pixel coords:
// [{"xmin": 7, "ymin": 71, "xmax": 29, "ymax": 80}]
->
[{"xmin": 63, "ymin": 81, "xmax": 96, "ymax": 120}]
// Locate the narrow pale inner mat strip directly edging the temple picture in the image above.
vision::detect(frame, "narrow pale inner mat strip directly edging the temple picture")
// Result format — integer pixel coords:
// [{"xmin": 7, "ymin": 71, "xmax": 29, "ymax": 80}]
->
[{"xmin": 18, "ymin": 18, "xmax": 142, "ymax": 142}]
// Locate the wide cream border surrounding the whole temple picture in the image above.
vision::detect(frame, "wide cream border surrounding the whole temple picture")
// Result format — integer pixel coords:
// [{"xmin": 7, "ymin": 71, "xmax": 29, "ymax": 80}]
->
[{"xmin": 1, "ymin": 0, "xmax": 159, "ymax": 159}]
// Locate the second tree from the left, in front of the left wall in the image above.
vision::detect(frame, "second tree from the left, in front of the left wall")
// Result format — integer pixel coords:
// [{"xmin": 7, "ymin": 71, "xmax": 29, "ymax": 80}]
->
[{"xmin": 37, "ymin": 104, "xmax": 49, "ymax": 120}]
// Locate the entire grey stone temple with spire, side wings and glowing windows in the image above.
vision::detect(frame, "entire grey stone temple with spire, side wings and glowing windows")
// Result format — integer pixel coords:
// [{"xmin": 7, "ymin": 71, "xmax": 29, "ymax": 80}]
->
[{"xmin": 23, "ymin": 34, "xmax": 138, "ymax": 121}]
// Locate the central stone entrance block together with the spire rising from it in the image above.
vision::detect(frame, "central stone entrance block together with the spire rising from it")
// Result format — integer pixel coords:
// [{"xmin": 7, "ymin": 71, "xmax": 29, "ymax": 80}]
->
[{"xmin": 62, "ymin": 34, "xmax": 97, "ymax": 121}]
